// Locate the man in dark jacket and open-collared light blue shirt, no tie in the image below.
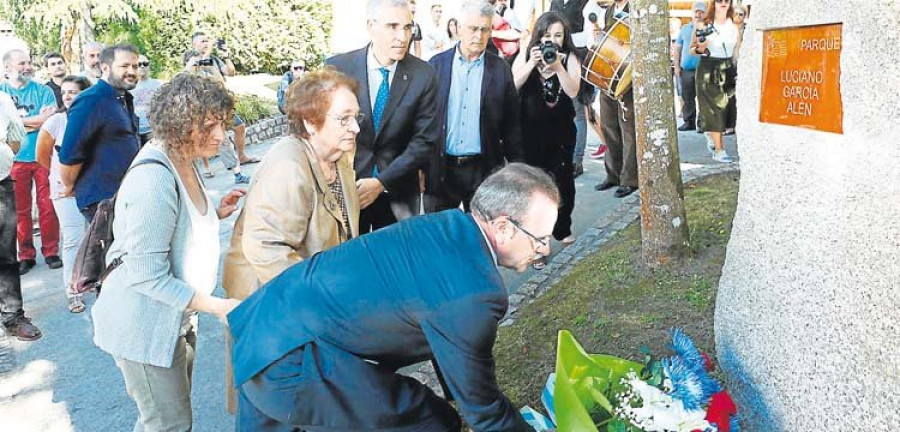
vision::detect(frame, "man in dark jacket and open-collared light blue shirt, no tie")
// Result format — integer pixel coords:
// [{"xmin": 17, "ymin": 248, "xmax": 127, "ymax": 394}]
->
[{"xmin": 426, "ymin": 0, "xmax": 523, "ymax": 211}]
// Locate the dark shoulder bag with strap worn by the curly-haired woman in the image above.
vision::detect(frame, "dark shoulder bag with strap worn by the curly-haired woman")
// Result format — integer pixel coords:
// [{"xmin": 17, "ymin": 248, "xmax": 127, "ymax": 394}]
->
[{"xmin": 70, "ymin": 159, "xmax": 181, "ymax": 295}]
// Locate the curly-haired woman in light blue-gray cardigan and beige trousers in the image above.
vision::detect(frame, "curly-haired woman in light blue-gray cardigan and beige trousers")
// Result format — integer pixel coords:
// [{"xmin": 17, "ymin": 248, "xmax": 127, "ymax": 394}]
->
[{"xmin": 91, "ymin": 73, "xmax": 244, "ymax": 431}]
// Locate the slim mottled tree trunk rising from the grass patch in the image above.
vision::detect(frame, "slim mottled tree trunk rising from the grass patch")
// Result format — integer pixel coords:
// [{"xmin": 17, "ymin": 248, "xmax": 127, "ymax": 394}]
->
[{"xmin": 631, "ymin": 0, "xmax": 690, "ymax": 268}]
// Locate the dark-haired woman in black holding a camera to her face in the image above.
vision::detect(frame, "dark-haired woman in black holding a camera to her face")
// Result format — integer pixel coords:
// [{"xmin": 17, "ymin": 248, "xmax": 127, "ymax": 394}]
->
[{"xmin": 513, "ymin": 12, "xmax": 581, "ymax": 269}]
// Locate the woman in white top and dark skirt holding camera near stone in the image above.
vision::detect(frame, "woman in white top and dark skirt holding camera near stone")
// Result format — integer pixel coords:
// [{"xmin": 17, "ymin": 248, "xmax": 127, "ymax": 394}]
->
[{"xmin": 691, "ymin": 0, "xmax": 741, "ymax": 163}]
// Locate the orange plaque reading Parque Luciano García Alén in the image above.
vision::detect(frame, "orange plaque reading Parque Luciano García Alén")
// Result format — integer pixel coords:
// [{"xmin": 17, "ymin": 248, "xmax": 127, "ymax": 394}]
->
[{"xmin": 759, "ymin": 24, "xmax": 844, "ymax": 134}]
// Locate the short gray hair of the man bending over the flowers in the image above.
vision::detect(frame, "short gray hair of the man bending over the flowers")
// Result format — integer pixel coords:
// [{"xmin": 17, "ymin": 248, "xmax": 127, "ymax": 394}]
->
[{"xmin": 471, "ymin": 163, "xmax": 560, "ymax": 220}]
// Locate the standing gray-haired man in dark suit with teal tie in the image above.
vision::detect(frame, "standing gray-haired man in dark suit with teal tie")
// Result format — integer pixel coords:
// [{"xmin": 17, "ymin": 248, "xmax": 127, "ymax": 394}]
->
[{"xmin": 325, "ymin": 0, "xmax": 438, "ymax": 233}]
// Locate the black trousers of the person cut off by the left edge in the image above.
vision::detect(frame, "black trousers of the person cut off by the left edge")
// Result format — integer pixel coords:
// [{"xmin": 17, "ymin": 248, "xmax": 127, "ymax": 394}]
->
[{"xmin": 0, "ymin": 177, "xmax": 25, "ymax": 325}]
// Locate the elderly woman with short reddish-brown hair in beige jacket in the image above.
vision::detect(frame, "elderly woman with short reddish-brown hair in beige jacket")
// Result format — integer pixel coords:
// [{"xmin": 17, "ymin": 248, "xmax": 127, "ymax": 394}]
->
[{"xmin": 222, "ymin": 68, "xmax": 362, "ymax": 412}]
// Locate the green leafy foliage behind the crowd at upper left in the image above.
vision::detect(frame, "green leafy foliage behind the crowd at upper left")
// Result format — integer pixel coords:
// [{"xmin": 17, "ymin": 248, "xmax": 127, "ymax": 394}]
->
[{"xmin": 0, "ymin": 0, "xmax": 332, "ymax": 77}]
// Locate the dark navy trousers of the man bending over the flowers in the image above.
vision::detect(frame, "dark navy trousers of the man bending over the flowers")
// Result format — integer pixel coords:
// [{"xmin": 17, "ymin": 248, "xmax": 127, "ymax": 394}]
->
[{"xmin": 235, "ymin": 342, "xmax": 462, "ymax": 432}]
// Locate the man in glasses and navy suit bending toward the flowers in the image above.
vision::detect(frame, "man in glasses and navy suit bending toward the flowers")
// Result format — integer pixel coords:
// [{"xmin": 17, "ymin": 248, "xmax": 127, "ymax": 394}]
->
[{"xmin": 228, "ymin": 163, "xmax": 559, "ymax": 432}]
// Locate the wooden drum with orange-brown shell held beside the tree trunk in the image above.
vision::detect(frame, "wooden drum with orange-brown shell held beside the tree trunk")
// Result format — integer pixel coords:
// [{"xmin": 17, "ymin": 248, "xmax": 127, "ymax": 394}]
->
[{"xmin": 581, "ymin": 19, "xmax": 631, "ymax": 99}]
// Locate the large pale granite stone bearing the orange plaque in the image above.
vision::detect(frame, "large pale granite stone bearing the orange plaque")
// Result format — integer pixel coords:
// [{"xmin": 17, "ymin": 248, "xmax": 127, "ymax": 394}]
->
[{"xmin": 715, "ymin": 0, "xmax": 900, "ymax": 432}]
